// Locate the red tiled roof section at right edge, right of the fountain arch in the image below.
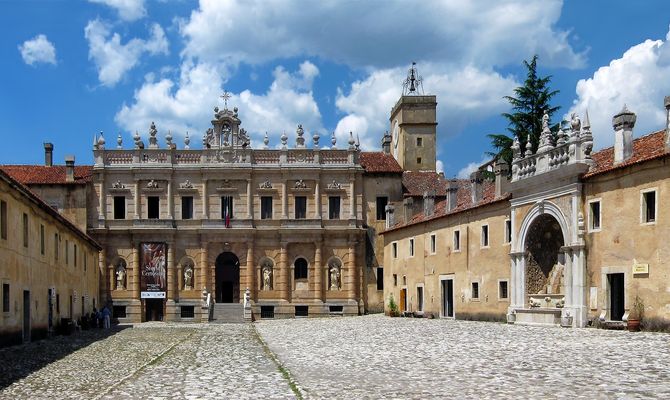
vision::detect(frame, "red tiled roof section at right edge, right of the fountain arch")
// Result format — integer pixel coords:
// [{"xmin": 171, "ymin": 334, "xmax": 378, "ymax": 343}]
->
[{"xmin": 584, "ymin": 130, "xmax": 669, "ymax": 178}]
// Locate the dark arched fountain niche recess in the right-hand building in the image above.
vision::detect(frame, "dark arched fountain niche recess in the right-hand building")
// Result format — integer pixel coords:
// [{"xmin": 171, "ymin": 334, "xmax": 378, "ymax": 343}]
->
[{"xmin": 524, "ymin": 214, "xmax": 565, "ymax": 298}]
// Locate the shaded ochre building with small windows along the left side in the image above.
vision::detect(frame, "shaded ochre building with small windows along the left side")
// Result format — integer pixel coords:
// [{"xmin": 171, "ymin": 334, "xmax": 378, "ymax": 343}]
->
[{"xmin": 0, "ymin": 167, "xmax": 101, "ymax": 346}]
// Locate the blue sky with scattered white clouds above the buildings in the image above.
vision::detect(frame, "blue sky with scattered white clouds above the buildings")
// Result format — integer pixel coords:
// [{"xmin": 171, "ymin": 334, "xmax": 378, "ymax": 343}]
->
[{"xmin": 0, "ymin": 0, "xmax": 670, "ymax": 176}]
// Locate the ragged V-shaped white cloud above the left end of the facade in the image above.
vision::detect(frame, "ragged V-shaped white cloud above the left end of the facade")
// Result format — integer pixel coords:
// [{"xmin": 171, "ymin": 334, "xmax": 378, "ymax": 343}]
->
[{"xmin": 84, "ymin": 19, "xmax": 168, "ymax": 87}]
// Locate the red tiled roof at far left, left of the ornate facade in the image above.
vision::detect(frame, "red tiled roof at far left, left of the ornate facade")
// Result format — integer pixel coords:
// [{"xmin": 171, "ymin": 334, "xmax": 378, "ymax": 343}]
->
[{"xmin": 0, "ymin": 165, "xmax": 93, "ymax": 185}]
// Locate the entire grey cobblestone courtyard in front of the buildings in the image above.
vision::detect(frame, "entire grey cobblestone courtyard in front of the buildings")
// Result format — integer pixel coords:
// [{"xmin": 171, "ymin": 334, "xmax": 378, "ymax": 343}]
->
[{"xmin": 0, "ymin": 315, "xmax": 670, "ymax": 399}]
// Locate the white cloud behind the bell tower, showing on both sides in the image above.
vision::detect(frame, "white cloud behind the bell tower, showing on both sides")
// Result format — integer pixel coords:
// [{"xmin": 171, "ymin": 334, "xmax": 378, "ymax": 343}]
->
[{"xmin": 335, "ymin": 63, "xmax": 519, "ymax": 149}]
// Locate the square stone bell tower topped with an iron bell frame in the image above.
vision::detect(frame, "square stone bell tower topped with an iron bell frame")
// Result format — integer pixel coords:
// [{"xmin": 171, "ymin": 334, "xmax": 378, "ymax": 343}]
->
[{"xmin": 390, "ymin": 62, "xmax": 437, "ymax": 171}]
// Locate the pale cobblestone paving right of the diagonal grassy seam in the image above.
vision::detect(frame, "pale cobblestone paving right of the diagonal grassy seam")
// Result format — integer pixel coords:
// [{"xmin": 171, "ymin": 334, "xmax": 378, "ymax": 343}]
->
[{"xmin": 256, "ymin": 315, "xmax": 670, "ymax": 399}]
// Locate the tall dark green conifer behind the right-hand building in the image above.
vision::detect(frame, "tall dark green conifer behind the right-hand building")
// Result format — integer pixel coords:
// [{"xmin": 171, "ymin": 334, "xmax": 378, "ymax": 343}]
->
[{"xmin": 488, "ymin": 55, "xmax": 560, "ymax": 166}]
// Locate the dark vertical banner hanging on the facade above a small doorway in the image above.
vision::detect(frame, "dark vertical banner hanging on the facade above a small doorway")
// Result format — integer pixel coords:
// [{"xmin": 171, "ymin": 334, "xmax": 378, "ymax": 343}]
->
[{"xmin": 140, "ymin": 243, "xmax": 167, "ymax": 299}]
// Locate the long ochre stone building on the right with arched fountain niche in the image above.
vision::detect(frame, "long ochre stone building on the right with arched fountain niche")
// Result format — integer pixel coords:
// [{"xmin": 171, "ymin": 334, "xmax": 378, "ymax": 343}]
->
[{"xmin": 382, "ymin": 98, "xmax": 670, "ymax": 327}]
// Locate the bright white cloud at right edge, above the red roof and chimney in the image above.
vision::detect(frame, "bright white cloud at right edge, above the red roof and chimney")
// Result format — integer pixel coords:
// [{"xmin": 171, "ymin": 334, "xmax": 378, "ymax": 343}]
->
[{"xmin": 569, "ymin": 26, "xmax": 670, "ymax": 148}]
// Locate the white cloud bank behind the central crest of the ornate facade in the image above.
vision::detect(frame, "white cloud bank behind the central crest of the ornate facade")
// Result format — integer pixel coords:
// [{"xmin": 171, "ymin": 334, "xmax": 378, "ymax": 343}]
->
[{"xmin": 116, "ymin": 61, "xmax": 325, "ymax": 147}]
